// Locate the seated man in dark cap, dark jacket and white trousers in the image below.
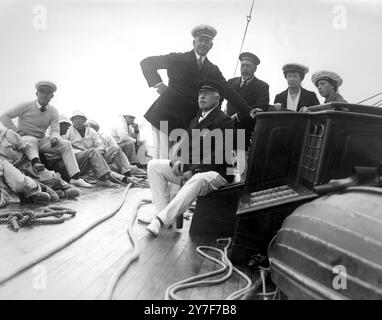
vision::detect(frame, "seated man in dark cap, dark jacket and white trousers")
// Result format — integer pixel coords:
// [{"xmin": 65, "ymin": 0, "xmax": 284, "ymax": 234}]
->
[{"xmin": 146, "ymin": 80, "xmax": 234, "ymax": 236}]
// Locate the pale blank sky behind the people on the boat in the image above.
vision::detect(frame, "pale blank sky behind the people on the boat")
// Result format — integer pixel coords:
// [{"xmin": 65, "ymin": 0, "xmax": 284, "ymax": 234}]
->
[{"xmin": 0, "ymin": 0, "xmax": 382, "ymax": 142}]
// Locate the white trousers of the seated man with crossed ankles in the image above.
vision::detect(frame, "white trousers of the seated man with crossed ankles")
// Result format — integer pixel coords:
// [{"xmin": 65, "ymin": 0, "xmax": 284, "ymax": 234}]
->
[{"xmin": 147, "ymin": 159, "xmax": 228, "ymax": 226}]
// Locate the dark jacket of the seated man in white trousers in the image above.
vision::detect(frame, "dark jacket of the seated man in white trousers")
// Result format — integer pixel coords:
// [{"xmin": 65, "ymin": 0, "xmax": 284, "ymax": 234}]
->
[{"xmin": 178, "ymin": 107, "xmax": 235, "ymax": 182}]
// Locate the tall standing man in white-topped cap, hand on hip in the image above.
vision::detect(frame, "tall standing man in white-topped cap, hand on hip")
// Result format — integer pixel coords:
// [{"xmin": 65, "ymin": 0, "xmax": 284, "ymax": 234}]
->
[{"xmin": 141, "ymin": 25, "xmax": 254, "ymax": 159}]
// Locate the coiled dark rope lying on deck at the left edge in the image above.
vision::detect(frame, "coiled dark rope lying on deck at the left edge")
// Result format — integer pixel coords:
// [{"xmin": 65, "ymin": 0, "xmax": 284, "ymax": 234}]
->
[{"xmin": 0, "ymin": 207, "xmax": 77, "ymax": 232}]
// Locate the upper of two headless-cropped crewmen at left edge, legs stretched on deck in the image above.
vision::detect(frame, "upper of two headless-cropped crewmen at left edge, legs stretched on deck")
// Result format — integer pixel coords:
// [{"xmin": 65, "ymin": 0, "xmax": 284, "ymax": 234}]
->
[{"xmin": 0, "ymin": 123, "xmax": 80, "ymax": 201}]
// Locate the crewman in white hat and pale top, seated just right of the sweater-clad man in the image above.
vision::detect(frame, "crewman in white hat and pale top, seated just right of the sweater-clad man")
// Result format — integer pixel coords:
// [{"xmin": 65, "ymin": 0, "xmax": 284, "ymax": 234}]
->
[{"xmin": 64, "ymin": 110, "xmax": 131, "ymax": 184}]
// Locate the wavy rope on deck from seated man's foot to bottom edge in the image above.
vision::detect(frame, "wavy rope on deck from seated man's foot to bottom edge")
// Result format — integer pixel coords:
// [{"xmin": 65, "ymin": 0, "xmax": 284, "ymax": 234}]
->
[{"xmin": 102, "ymin": 199, "xmax": 151, "ymax": 300}]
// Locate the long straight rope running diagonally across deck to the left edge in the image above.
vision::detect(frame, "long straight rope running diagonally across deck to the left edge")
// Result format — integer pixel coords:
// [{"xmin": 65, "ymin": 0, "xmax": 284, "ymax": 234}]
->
[{"xmin": 0, "ymin": 183, "xmax": 132, "ymax": 285}]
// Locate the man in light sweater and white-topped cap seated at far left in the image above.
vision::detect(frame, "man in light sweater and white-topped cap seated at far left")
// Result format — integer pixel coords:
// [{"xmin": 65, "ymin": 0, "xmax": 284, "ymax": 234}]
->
[{"xmin": 0, "ymin": 81, "xmax": 88, "ymax": 187}]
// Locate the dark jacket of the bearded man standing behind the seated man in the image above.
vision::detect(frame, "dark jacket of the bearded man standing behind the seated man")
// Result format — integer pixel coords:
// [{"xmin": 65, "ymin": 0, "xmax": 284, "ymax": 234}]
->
[{"xmin": 227, "ymin": 77, "xmax": 269, "ymax": 116}]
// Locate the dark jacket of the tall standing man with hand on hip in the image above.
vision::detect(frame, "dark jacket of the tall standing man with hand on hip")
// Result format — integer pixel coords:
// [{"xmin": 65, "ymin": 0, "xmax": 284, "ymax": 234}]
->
[{"xmin": 141, "ymin": 50, "xmax": 250, "ymax": 132}]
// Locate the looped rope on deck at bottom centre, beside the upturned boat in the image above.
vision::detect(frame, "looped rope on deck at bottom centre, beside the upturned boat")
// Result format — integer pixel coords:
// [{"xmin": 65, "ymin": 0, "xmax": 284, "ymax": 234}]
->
[{"xmin": 165, "ymin": 238, "xmax": 252, "ymax": 300}]
